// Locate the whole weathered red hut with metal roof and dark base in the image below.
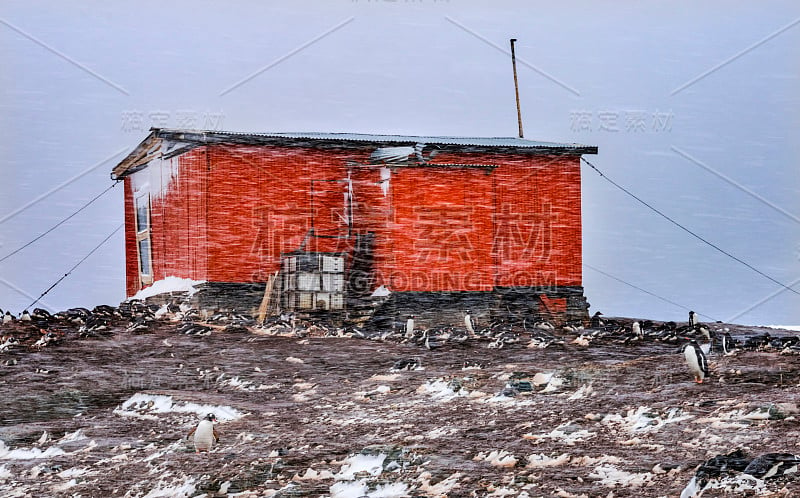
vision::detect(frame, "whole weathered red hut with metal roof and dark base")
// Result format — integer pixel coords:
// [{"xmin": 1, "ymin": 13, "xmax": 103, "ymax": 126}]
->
[{"xmin": 112, "ymin": 128, "xmax": 597, "ymax": 319}]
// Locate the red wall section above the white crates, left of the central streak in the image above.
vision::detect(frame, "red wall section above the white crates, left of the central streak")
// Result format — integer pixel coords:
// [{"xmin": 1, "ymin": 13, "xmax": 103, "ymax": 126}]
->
[{"xmin": 208, "ymin": 146, "xmax": 360, "ymax": 282}]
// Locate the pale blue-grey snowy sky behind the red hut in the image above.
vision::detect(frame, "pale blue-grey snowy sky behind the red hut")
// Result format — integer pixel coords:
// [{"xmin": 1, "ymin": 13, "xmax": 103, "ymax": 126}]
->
[{"xmin": 0, "ymin": 0, "xmax": 800, "ymax": 324}]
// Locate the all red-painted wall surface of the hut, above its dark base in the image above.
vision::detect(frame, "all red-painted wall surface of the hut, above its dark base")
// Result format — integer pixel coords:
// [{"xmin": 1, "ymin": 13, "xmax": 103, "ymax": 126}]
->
[{"xmin": 126, "ymin": 145, "xmax": 581, "ymax": 294}]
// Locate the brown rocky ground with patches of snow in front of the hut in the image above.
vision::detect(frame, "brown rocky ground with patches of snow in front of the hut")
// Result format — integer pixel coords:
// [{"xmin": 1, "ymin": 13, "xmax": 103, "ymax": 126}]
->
[{"xmin": 0, "ymin": 310, "xmax": 800, "ymax": 497}]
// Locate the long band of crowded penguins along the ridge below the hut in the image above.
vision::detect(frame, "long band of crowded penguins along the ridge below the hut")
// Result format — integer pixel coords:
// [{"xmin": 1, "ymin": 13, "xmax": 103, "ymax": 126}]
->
[{"xmin": 0, "ymin": 299, "xmax": 800, "ymax": 370}]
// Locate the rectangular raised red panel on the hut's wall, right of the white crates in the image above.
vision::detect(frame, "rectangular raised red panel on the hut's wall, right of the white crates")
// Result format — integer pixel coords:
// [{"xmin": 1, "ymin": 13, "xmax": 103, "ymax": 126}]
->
[{"xmin": 389, "ymin": 167, "xmax": 494, "ymax": 291}]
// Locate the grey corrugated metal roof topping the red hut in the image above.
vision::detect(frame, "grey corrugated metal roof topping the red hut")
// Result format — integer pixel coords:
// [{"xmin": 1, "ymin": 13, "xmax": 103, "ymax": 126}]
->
[{"xmin": 154, "ymin": 128, "xmax": 591, "ymax": 149}]
